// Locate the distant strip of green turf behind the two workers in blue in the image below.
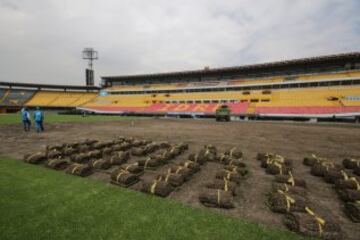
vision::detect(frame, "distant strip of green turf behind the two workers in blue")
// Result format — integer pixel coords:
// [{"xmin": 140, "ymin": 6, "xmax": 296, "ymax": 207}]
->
[{"xmin": 0, "ymin": 113, "xmax": 142, "ymax": 124}]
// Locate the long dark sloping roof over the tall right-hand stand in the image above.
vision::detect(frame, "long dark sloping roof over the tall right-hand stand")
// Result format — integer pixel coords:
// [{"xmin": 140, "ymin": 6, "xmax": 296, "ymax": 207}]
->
[{"xmin": 102, "ymin": 52, "xmax": 360, "ymax": 81}]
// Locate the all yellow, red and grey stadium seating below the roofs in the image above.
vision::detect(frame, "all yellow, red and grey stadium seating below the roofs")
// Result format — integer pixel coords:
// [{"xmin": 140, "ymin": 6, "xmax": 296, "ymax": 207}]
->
[{"xmin": 0, "ymin": 61, "xmax": 360, "ymax": 116}]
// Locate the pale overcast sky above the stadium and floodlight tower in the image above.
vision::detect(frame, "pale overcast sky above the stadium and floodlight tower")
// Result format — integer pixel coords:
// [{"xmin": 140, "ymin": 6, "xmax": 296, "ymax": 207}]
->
[{"xmin": 0, "ymin": 0, "xmax": 360, "ymax": 84}]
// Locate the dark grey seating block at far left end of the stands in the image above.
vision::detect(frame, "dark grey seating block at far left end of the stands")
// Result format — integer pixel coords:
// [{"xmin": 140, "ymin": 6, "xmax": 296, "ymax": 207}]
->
[{"xmin": 0, "ymin": 89, "xmax": 35, "ymax": 106}]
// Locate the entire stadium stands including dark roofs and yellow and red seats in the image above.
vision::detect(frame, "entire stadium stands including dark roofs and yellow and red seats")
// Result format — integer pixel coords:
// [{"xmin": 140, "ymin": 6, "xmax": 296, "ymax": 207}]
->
[{"xmin": 0, "ymin": 52, "xmax": 360, "ymax": 119}]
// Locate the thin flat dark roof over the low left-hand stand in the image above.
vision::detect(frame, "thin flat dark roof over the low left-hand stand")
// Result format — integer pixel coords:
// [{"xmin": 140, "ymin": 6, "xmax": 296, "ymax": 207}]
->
[{"xmin": 0, "ymin": 82, "xmax": 100, "ymax": 91}]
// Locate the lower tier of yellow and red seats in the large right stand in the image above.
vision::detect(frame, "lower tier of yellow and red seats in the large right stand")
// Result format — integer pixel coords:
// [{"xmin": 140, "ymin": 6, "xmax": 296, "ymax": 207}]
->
[{"xmin": 82, "ymin": 83, "xmax": 360, "ymax": 115}]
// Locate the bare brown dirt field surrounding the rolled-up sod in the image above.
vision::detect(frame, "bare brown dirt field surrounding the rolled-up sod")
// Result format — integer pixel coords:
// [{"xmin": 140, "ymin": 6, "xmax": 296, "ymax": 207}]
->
[{"xmin": 0, "ymin": 119, "xmax": 360, "ymax": 240}]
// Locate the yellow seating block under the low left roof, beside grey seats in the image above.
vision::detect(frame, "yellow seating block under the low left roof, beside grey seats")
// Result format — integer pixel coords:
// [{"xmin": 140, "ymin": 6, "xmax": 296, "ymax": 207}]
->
[{"xmin": 26, "ymin": 91, "xmax": 97, "ymax": 107}]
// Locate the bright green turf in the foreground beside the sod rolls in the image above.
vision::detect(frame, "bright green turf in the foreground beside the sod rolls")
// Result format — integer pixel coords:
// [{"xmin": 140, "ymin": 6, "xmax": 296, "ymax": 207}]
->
[{"xmin": 0, "ymin": 157, "xmax": 308, "ymax": 240}]
